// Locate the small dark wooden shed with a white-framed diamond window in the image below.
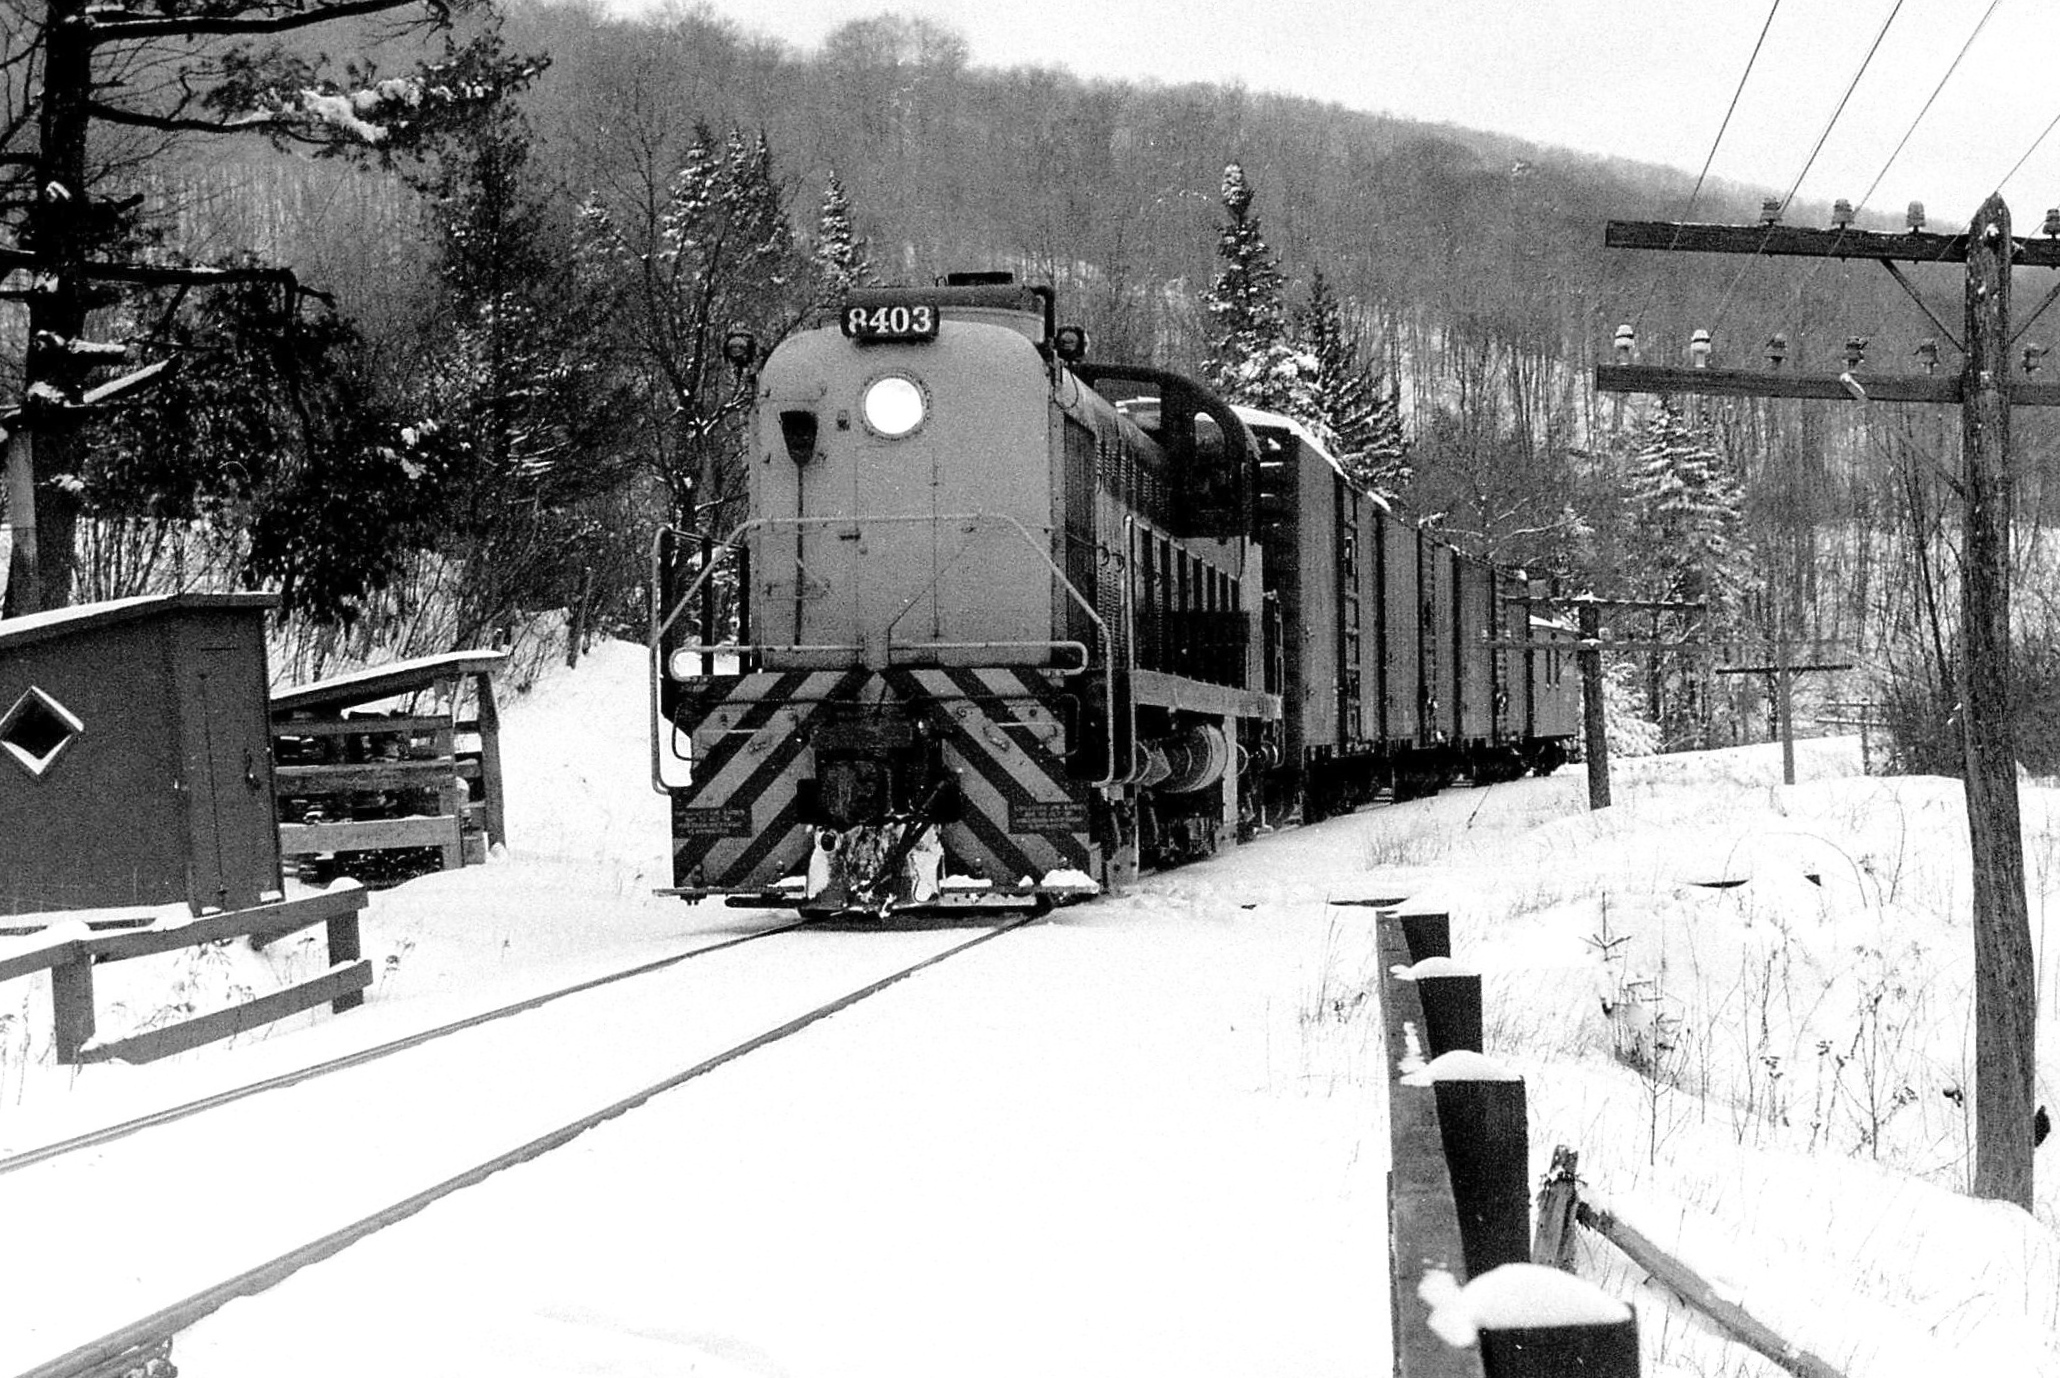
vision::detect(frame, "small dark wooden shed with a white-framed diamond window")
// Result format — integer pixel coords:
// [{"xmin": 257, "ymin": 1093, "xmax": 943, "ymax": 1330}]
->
[{"xmin": 0, "ymin": 593, "xmax": 280, "ymax": 915}]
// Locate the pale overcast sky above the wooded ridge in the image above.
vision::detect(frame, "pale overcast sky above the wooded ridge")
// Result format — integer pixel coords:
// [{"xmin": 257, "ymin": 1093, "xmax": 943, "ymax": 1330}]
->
[{"xmin": 667, "ymin": 0, "xmax": 2060, "ymax": 233}]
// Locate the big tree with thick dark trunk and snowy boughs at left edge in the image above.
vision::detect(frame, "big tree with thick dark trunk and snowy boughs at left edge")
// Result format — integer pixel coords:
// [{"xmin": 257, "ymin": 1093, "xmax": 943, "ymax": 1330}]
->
[{"xmin": 0, "ymin": 0, "xmax": 542, "ymax": 616}]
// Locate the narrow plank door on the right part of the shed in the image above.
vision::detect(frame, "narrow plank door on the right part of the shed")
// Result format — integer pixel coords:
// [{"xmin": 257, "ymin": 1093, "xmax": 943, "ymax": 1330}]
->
[{"xmin": 181, "ymin": 645, "xmax": 280, "ymax": 908}]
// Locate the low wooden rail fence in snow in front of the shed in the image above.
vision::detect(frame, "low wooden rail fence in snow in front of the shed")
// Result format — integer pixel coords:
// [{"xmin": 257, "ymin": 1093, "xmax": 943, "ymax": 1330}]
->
[{"xmin": 0, "ymin": 886, "xmax": 373, "ymax": 1065}]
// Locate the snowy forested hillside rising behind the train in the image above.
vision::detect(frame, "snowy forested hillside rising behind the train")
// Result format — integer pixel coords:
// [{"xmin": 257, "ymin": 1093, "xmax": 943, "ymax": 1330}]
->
[{"xmin": 8, "ymin": 0, "xmax": 2060, "ymax": 762}]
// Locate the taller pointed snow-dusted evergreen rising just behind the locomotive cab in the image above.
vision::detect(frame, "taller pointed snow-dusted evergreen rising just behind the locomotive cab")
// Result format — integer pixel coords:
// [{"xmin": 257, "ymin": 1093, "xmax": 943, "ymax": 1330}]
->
[{"xmin": 1203, "ymin": 163, "xmax": 1318, "ymax": 418}]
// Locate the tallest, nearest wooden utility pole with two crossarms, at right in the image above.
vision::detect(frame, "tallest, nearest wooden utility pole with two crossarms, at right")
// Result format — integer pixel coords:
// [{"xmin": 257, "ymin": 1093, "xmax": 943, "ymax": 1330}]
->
[{"xmin": 1594, "ymin": 196, "xmax": 2060, "ymax": 1211}]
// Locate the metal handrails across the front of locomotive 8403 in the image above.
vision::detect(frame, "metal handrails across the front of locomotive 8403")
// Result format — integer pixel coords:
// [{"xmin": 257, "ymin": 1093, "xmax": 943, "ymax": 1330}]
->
[{"xmin": 651, "ymin": 513, "xmax": 1117, "ymax": 795}]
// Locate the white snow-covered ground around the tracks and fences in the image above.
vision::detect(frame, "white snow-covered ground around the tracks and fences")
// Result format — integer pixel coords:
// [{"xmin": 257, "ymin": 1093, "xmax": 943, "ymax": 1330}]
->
[{"xmin": 0, "ymin": 645, "xmax": 2060, "ymax": 1378}]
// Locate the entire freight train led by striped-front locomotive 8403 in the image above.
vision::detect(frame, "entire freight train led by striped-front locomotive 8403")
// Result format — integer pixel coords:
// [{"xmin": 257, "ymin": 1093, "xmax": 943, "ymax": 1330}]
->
[{"xmin": 651, "ymin": 274, "xmax": 1572, "ymax": 912}]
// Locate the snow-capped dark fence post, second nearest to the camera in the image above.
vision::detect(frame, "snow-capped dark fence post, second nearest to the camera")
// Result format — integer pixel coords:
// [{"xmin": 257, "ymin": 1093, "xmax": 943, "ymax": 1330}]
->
[{"xmin": 1403, "ymin": 1050, "xmax": 1531, "ymax": 1277}]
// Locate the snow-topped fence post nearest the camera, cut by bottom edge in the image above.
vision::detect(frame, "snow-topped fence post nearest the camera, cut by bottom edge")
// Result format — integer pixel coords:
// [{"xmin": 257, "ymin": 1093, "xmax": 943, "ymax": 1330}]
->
[{"xmin": 1423, "ymin": 1263, "xmax": 1638, "ymax": 1378}]
